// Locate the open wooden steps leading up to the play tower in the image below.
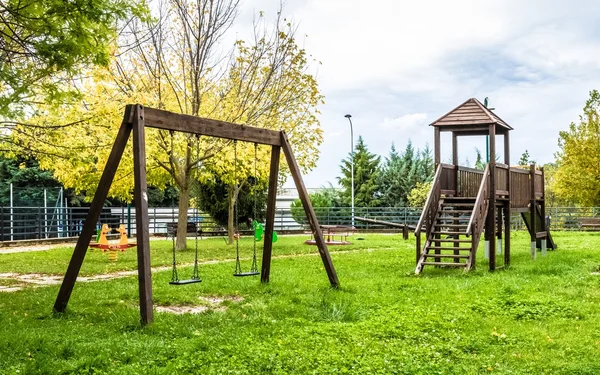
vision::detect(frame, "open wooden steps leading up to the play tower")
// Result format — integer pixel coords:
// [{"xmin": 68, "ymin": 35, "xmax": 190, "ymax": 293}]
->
[{"xmin": 415, "ymin": 197, "xmax": 476, "ymax": 274}]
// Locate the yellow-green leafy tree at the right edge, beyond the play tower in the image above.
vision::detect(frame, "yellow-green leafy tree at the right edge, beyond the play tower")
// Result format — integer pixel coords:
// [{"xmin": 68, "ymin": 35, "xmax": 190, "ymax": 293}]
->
[{"xmin": 555, "ymin": 90, "xmax": 600, "ymax": 206}]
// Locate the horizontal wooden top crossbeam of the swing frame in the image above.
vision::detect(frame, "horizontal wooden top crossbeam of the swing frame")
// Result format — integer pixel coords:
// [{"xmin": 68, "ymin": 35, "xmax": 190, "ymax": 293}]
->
[{"xmin": 144, "ymin": 108, "xmax": 281, "ymax": 146}]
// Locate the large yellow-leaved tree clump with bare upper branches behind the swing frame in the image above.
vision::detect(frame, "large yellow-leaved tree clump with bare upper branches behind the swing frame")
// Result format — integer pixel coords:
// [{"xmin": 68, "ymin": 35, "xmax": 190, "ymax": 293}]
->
[{"xmin": 5, "ymin": 0, "xmax": 323, "ymax": 249}]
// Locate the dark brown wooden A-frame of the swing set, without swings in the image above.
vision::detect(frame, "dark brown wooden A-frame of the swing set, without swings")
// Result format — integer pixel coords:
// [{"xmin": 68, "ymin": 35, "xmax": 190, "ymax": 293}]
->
[{"xmin": 54, "ymin": 104, "xmax": 339, "ymax": 325}]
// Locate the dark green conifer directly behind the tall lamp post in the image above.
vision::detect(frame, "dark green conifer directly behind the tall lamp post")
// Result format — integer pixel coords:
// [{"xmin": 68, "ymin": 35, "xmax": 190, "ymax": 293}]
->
[{"xmin": 338, "ymin": 136, "xmax": 381, "ymax": 207}]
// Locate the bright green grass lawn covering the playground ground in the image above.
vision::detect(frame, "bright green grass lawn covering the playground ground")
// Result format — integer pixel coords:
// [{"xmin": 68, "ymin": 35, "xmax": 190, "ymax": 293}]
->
[{"xmin": 0, "ymin": 232, "xmax": 600, "ymax": 374}]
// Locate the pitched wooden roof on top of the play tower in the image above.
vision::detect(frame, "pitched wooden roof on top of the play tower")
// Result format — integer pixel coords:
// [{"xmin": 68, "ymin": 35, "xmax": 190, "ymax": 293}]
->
[{"xmin": 431, "ymin": 98, "xmax": 513, "ymax": 132}]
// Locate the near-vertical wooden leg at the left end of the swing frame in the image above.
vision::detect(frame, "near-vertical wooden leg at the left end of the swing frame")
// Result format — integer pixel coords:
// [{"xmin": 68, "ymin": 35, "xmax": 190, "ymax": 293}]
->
[{"xmin": 132, "ymin": 104, "xmax": 154, "ymax": 325}]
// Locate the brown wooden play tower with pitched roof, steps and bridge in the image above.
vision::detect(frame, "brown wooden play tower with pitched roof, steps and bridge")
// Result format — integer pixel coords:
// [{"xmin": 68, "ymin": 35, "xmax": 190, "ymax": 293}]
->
[{"xmin": 415, "ymin": 98, "xmax": 556, "ymax": 274}]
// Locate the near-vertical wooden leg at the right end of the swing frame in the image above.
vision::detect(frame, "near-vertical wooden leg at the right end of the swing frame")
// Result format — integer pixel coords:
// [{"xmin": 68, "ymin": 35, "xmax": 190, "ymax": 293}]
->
[{"xmin": 260, "ymin": 146, "xmax": 281, "ymax": 283}]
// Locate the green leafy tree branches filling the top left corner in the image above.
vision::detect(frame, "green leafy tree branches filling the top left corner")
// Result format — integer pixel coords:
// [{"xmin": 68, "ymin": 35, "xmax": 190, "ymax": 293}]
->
[{"xmin": 0, "ymin": 0, "xmax": 148, "ymax": 118}]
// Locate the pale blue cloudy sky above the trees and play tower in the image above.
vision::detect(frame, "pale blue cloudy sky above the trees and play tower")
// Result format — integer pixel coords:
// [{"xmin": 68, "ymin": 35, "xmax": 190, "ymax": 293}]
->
[{"xmin": 231, "ymin": 0, "xmax": 600, "ymax": 187}]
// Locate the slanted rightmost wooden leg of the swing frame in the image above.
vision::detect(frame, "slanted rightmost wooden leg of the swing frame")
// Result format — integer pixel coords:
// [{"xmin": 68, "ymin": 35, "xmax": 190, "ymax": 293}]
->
[{"xmin": 281, "ymin": 131, "xmax": 340, "ymax": 288}]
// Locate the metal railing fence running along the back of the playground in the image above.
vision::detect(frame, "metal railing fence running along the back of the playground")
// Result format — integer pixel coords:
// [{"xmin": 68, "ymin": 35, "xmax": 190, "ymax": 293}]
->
[{"xmin": 0, "ymin": 207, "xmax": 600, "ymax": 241}]
